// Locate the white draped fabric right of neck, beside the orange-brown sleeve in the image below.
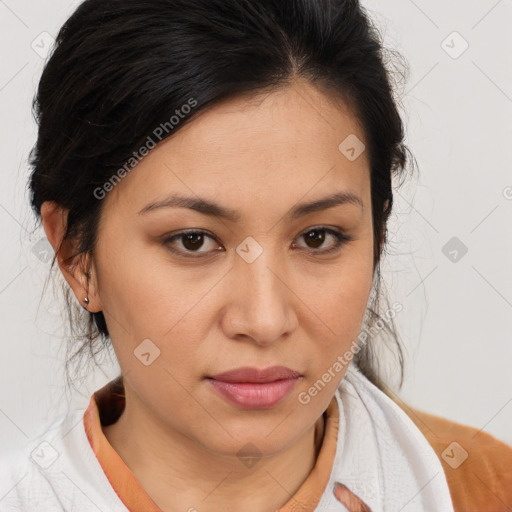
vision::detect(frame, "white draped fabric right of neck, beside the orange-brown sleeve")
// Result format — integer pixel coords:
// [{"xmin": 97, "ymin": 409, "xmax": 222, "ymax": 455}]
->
[{"xmin": 315, "ymin": 364, "xmax": 453, "ymax": 512}]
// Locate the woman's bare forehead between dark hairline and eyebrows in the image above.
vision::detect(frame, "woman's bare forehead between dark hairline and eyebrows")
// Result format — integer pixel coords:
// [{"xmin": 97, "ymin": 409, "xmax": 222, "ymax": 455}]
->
[{"xmin": 107, "ymin": 79, "xmax": 370, "ymax": 214}]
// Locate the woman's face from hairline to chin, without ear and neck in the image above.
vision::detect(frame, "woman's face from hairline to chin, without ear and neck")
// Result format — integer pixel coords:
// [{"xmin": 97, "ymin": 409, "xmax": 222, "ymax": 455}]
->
[{"xmin": 91, "ymin": 82, "xmax": 373, "ymax": 455}]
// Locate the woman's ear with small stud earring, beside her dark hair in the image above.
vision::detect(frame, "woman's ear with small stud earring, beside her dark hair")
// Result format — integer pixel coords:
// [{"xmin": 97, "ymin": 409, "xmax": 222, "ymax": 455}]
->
[{"xmin": 41, "ymin": 201, "xmax": 101, "ymax": 313}]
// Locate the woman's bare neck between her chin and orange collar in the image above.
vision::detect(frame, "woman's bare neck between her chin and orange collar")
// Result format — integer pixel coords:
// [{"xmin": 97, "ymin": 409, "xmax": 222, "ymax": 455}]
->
[{"xmin": 103, "ymin": 388, "xmax": 325, "ymax": 512}]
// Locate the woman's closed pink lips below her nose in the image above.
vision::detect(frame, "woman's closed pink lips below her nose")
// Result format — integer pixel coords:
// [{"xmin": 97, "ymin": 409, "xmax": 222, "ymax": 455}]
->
[{"xmin": 208, "ymin": 366, "xmax": 301, "ymax": 409}]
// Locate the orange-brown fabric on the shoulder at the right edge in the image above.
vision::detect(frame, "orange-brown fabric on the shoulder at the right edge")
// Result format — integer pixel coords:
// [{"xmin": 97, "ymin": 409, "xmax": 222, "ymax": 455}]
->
[{"xmin": 392, "ymin": 397, "xmax": 512, "ymax": 512}]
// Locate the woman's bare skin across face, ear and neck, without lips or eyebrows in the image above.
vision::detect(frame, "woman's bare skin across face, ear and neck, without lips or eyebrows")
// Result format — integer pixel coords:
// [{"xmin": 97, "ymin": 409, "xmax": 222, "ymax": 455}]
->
[{"xmin": 42, "ymin": 81, "xmax": 374, "ymax": 512}]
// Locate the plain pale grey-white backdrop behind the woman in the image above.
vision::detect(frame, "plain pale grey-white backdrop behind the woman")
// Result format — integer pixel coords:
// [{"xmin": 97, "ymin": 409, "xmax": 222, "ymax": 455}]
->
[{"xmin": 0, "ymin": 0, "xmax": 512, "ymax": 456}]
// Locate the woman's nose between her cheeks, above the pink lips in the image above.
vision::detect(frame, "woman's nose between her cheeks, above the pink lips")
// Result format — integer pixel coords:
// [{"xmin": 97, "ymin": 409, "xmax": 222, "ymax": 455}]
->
[{"xmin": 222, "ymin": 246, "xmax": 297, "ymax": 346}]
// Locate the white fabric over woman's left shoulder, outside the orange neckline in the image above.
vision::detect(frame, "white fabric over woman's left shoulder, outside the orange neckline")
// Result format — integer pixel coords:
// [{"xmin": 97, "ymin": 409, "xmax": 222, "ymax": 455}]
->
[{"xmin": 0, "ymin": 409, "xmax": 128, "ymax": 512}]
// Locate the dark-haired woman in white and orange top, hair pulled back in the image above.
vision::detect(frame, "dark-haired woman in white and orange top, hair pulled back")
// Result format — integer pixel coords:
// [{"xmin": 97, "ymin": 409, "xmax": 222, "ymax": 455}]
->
[{"xmin": 0, "ymin": 0, "xmax": 512, "ymax": 512}]
